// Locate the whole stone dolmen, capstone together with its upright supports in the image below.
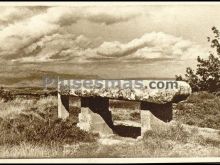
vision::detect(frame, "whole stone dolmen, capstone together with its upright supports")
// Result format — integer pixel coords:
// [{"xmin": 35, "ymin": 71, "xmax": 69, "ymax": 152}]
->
[{"xmin": 58, "ymin": 80, "xmax": 191, "ymax": 136}]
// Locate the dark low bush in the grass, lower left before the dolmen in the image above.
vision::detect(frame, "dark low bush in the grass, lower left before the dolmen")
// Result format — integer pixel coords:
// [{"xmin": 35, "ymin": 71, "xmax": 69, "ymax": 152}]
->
[{"xmin": 0, "ymin": 115, "xmax": 95, "ymax": 145}]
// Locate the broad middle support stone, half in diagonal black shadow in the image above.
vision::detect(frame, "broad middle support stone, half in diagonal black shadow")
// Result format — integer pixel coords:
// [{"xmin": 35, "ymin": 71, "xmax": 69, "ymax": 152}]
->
[{"xmin": 77, "ymin": 97, "xmax": 113, "ymax": 135}]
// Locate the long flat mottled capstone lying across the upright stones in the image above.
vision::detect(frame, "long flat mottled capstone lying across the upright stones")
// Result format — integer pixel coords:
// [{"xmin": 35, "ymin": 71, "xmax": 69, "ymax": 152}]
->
[{"xmin": 58, "ymin": 80, "xmax": 191, "ymax": 104}]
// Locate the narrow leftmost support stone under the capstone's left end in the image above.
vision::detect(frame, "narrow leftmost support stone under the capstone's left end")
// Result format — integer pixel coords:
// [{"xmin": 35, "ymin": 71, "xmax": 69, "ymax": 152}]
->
[{"xmin": 58, "ymin": 93, "xmax": 69, "ymax": 120}]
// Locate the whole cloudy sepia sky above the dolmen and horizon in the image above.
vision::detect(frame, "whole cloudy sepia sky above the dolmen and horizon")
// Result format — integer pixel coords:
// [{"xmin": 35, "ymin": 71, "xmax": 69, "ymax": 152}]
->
[{"xmin": 0, "ymin": 4, "xmax": 220, "ymax": 78}]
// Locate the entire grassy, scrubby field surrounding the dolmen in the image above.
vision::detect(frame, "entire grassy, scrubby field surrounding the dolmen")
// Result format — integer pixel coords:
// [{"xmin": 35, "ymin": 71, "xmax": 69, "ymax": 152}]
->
[{"xmin": 0, "ymin": 88, "xmax": 220, "ymax": 158}]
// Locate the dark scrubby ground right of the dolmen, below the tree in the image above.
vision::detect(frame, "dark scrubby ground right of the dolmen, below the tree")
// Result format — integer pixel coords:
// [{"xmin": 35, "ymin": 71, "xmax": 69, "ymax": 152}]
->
[{"xmin": 174, "ymin": 92, "xmax": 220, "ymax": 129}]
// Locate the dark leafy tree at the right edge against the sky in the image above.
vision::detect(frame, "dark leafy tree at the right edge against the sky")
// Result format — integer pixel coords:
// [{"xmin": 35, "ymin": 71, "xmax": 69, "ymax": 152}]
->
[{"xmin": 176, "ymin": 27, "xmax": 220, "ymax": 92}]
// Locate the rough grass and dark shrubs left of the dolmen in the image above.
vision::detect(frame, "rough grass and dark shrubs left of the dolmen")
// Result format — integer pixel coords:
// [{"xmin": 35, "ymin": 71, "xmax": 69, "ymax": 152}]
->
[{"xmin": 0, "ymin": 97, "xmax": 96, "ymax": 145}]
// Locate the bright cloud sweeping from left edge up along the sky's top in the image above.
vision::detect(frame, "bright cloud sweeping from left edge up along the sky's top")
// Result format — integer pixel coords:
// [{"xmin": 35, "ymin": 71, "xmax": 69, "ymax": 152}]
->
[{"xmin": 0, "ymin": 7, "xmax": 143, "ymax": 59}]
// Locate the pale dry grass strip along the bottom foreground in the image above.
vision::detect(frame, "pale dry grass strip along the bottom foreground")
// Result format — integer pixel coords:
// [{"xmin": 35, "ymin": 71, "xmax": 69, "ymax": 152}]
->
[{"xmin": 0, "ymin": 122, "xmax": 220, "ymax": 158}]
